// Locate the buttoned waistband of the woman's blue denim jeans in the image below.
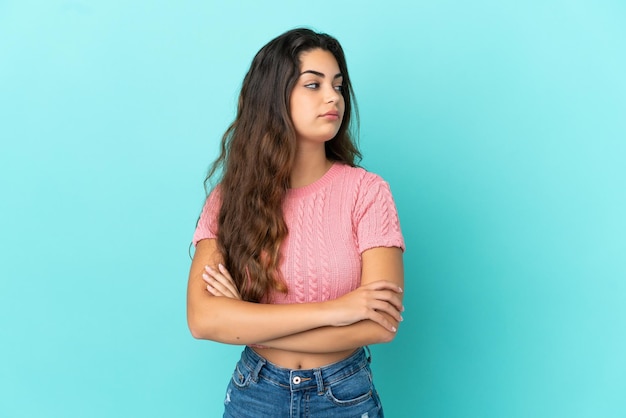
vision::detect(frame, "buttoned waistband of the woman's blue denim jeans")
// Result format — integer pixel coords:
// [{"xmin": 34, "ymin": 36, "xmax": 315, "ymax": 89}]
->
[{"xmin": 241, "ymin": 347, "xmax": 371, "ymax": 394}]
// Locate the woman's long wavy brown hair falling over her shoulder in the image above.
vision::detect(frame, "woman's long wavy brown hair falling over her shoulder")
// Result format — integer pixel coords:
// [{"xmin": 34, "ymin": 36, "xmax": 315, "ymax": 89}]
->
[{"xmin": 205, "ymin": 28, "xmax": 361, "ymax": 302}]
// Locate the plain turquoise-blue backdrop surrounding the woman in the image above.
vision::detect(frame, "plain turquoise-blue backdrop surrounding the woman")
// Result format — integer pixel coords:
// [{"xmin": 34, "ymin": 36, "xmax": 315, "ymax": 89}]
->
[{"xmin": 0, "ymin": 0, "xmax": 626, "ymax": 418}]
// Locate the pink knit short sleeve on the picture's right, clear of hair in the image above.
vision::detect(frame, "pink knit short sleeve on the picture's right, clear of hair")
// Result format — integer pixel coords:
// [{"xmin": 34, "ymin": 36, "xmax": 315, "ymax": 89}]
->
[{"xmin": 353, "ymin": 173, "xmax": 405, "ymax": 253}]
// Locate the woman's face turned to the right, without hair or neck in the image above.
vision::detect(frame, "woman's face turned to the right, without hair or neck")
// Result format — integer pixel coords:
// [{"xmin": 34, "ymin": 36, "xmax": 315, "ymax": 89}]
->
[{"xmin": 289, "ymin": 48, "xmax": 345, "ymax": 144}]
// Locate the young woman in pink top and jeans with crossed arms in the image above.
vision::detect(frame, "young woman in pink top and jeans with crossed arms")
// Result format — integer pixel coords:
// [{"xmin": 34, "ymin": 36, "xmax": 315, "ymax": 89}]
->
[{"xmin": 187, "ymin": 29, "xmax": 404, "ymax": 418}]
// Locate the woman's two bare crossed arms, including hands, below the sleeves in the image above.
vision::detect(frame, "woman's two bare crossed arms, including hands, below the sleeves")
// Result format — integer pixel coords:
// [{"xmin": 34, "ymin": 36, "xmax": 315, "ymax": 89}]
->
[{"xmin": 187, "ymin": 239, "xmax": 404, "ymax": 353}]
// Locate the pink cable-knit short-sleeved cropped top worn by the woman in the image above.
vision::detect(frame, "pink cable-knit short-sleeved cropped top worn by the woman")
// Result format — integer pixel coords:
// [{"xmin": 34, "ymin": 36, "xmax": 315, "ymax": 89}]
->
[{"xmin": 193, "ymin": 163, "xmax": 405, "ymax": 304}]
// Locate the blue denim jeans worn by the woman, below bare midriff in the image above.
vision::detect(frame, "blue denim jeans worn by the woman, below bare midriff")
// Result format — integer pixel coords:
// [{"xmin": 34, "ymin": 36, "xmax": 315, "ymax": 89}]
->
[{"xmin": 224, "ymin": 347, "xmax": 384, "ymax": 418}]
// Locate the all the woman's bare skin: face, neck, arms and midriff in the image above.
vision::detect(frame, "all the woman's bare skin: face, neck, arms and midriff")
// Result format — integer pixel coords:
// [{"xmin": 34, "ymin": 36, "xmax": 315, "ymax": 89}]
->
[{"xmin": 187, "ymin": 49, "xmax": 404, "ymax": 369}]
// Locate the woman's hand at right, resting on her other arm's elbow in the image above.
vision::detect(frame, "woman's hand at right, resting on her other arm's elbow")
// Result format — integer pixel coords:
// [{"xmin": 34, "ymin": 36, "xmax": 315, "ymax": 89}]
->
[{"xmin": 327, "ymin": 280, "xmax": 404, "ymax": 332}]
